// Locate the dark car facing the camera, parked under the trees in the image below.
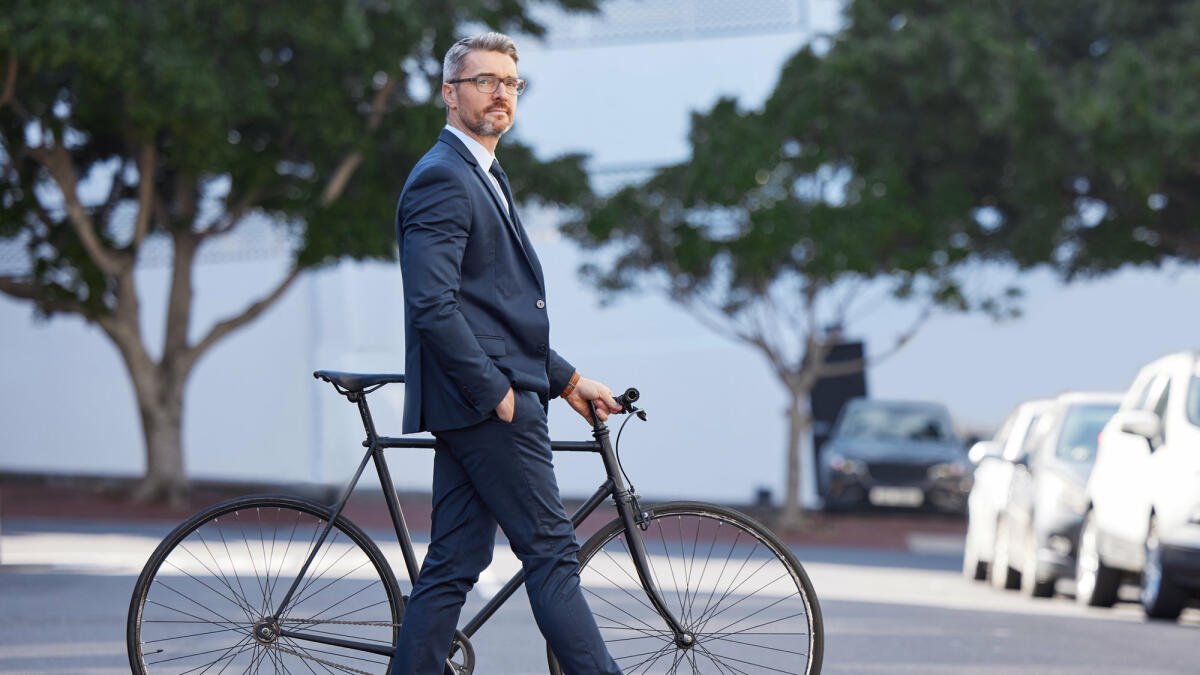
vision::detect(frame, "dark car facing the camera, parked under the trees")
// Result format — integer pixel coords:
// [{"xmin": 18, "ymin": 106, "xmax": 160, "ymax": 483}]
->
[{"xmin": 820, "ymin": 399, "xmax": 972, "ymax": 512}]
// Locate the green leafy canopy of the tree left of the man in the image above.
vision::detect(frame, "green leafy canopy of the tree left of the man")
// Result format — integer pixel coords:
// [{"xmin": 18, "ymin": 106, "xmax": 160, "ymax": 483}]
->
[{"xmin": 0, "ymin": 0, "xmax": 595, "ymax": 312}]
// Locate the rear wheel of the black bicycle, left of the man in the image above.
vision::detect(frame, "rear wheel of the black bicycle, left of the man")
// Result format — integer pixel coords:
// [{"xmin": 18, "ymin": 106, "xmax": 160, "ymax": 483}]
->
[{"xmin": 126, "ymin": 495, "xmax": 404, "ymax": 675}]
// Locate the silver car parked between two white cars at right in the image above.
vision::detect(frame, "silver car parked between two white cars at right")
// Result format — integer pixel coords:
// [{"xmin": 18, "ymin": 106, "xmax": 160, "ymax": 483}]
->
[{"xmin": 991, "ymin": 393, "xmax": 1121, "ymax": 597}]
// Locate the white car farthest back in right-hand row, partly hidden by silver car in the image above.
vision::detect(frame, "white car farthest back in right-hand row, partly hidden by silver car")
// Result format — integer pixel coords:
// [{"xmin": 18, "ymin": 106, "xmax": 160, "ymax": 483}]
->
[{"xmin": 962, "ymin": 399, "xmax": 1050, "ymax": 581}]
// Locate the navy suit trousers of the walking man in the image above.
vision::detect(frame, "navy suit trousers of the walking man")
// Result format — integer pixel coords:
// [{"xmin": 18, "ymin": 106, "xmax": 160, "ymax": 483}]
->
[{"xmin": 391, "ymin": 390, "xmax": 620, "ymax": 675}]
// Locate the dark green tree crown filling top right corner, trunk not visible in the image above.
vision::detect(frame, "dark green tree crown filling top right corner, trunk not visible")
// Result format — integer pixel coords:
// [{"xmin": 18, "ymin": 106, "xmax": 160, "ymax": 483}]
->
[{"xmin": 781, "ymin": 0, "xmax": 1200, "ymax": 279}]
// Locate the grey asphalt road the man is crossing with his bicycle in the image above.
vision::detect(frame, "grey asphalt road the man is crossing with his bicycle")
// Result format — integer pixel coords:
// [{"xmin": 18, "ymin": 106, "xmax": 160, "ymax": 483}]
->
[{"xmin": 0, "ymin": 520, "xmax": 1200, "ymax": 675}]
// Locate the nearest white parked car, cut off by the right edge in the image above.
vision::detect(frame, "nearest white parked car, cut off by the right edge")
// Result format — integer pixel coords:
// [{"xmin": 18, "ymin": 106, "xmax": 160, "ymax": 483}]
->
[{"xmin": 1075, "ymin": 352, "xmax": 1200, "ymax": 619}]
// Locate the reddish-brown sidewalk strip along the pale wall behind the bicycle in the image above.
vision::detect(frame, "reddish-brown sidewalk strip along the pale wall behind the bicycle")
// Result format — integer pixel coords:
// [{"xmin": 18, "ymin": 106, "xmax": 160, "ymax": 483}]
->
[{"xmin": 0, "ymin": 476, "xmax": 966, "ymax": 555}]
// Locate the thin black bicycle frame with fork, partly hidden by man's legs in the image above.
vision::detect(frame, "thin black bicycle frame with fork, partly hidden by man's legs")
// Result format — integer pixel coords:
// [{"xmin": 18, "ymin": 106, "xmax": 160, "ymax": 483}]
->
[{"xmin": 266, "ymin": 392, "xmax": 695, "ymax": 656}]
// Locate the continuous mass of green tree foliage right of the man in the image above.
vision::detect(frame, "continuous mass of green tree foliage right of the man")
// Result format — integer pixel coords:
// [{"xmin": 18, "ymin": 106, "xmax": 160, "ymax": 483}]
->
[{"xmin": 566, "ymin": 0, "xmax": 1200, "ymax": 311}]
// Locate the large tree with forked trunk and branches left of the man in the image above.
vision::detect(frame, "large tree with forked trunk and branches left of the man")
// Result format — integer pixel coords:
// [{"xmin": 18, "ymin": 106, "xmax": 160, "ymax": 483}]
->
[{"xmin": 0, "ymin": 0, "xmax": 594, "ymax": 500}]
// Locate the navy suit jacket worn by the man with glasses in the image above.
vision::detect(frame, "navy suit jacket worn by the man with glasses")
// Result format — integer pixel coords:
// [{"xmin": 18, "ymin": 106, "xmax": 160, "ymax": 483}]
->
[{"xmin": 396, "ymin": 130, "xmax": 575, "ymax": 434}]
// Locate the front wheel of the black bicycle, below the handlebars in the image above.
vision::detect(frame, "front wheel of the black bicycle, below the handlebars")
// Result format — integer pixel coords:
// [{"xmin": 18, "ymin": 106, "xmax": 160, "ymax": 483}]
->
[{"xmin": 546, "ymin": 502, "xmax": 824, "ymax": 675}]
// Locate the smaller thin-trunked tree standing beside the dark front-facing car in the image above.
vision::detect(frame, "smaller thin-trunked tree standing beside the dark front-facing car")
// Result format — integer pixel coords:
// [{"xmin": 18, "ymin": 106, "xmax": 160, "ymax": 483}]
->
[{"xmin": 565, "ymin": 93, "xmax": 988, "ymax": 525}]
